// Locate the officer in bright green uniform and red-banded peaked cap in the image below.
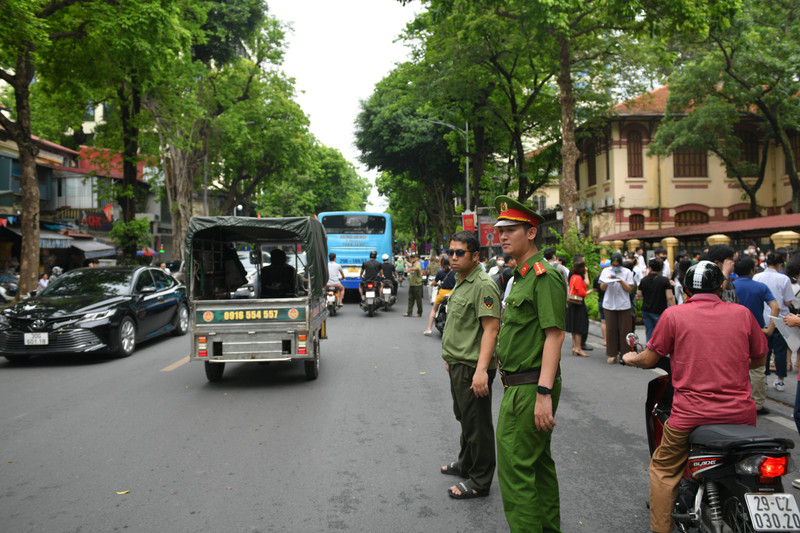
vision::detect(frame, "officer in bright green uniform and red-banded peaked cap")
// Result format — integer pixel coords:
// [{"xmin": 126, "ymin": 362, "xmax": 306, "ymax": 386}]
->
[{"xmin": 495, "ymin": 196, "xmax": 567, "ymax": 533}]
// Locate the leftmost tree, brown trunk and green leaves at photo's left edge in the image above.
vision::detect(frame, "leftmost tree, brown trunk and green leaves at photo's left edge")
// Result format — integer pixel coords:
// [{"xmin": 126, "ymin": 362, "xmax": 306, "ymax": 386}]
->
[{"xmin": 0, "ymin": 0, "xmax": 91, "ymax": 294}]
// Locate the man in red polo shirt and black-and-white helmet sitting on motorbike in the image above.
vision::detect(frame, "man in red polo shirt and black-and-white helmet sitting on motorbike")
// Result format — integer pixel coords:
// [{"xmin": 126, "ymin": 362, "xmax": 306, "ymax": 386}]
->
[{"xmin": 622, "ymin": 261, "xmax": 767, "ymax": 533}]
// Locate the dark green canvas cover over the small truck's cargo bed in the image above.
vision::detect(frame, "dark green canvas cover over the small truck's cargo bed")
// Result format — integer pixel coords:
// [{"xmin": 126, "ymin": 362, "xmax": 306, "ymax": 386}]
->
[{"xmin": 185, "ymin": 217, "xmax": 328, "ymax": 298}]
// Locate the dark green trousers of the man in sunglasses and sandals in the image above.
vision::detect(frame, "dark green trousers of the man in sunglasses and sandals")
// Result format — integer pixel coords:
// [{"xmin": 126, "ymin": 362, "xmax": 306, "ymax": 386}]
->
[{"xmin": 450, "ymin": 364, "xmax": 497, "ymax": 492}]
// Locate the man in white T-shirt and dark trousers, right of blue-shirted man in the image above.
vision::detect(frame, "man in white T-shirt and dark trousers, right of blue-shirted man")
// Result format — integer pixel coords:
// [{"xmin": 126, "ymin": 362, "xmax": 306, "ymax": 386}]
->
[{"xmin": 753, "ymin": 252, "xmax": 794, "ymax": 392}]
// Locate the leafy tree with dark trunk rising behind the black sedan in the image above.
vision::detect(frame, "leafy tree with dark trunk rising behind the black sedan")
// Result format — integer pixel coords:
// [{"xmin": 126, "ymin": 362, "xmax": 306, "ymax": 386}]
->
[{"xmin": 43, "ymin": 0, "xmax": 205, "ymax": 255}]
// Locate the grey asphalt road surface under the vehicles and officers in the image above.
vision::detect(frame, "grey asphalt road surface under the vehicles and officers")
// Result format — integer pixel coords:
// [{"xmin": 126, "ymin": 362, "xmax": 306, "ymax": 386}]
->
[{"xmin": 0, "ymin": 287, "xmax": 797, "ymax": 533}]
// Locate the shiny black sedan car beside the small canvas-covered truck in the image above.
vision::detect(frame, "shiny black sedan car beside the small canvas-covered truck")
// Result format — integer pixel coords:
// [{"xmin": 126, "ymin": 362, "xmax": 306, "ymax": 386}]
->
[{"xmin": 0, "ymin": 266, "xmax": 189, "ymax": 362}]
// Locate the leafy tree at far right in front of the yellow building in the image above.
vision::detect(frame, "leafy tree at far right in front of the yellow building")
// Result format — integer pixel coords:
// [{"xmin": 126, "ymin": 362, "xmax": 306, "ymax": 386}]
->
[{"xmin": 660, "ymin": 0, "xmax": 800, "ymax": 214}]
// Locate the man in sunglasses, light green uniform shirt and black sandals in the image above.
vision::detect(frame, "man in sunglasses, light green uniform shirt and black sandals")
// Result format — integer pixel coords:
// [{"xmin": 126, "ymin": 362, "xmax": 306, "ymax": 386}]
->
[{"xmin": 442, "ymin": 231, "xmax": 501, "ymax": 499}]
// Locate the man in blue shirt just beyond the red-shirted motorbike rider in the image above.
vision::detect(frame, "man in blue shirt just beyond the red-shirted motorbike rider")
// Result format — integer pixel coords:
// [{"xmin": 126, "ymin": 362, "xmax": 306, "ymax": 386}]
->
[{"xmin": 733, "ymin": 256, "xmax": 780, "ymax": 415}]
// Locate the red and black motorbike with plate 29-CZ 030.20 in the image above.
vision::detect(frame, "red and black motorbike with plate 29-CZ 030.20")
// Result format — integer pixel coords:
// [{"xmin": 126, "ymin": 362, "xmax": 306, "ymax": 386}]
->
[{"xmin": 622, "ymin": 333, "xmax": 800, "ymax": 533}]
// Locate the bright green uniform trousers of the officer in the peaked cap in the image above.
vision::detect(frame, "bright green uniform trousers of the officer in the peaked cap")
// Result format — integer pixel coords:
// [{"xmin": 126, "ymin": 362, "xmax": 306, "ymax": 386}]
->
[{"xmin": 497, "ymin": 378, "xmax": 561, "ymax": 533}]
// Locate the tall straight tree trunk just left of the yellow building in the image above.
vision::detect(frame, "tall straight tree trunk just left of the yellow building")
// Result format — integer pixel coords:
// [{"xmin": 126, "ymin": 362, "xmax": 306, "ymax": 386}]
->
[{"xmin": 558, "ymin": 35, "xmax": 580, "ymax": 237}]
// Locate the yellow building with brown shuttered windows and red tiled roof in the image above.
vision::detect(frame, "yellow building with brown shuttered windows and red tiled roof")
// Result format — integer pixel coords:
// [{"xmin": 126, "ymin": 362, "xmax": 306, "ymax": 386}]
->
[{"xmin": 577, "ymin": 87, "xmax": 800, "ymax": 246}]
